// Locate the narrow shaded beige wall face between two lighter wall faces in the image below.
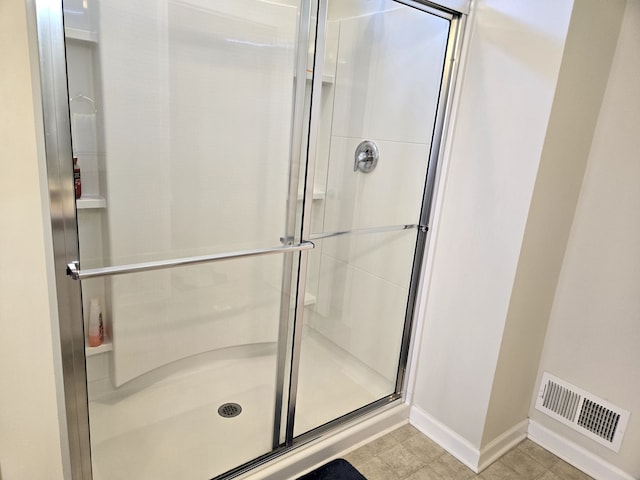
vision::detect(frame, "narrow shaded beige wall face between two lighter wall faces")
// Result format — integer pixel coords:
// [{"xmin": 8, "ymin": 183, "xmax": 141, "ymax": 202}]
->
[{"xmin": 482, "ymin": 0, "xmax": 625, "ymax": 445}]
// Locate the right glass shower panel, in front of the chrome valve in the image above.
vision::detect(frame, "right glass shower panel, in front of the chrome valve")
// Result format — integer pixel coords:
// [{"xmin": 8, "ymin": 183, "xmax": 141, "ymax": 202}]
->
[{"xmin": 295, "ymin": 0, "xmax": 450, "ymax": 435}]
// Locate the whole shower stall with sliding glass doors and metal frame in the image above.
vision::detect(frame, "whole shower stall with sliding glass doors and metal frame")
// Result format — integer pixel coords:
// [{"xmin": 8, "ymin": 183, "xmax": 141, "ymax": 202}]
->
[{"xmin": 36, "ymin": 0, "xmax": 460, "ymax": 480}]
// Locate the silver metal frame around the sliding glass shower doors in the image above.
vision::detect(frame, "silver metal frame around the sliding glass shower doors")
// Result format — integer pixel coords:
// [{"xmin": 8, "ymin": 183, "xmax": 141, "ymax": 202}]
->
[{"xmin": 33, "ymin": 0, "xmax": 466, "ymax": 480}]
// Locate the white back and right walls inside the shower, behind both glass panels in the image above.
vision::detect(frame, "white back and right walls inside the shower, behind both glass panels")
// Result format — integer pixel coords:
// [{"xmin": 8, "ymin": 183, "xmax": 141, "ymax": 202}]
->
[{"xmin": 87, "ymin": 0, "xmax": 448, "ymax": 390}]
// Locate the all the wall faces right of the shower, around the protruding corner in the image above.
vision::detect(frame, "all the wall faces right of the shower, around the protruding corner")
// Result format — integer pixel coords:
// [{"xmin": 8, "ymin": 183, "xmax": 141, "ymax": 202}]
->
[{"xmin": 412, "ymin": 0, "xmax": 640, "ymax": 479}]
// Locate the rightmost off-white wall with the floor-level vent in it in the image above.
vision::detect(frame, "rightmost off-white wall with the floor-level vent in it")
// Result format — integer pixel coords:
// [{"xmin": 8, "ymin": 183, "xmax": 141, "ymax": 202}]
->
[{"xmin": 530, "ymin": 0, "xmax": 640, "ymax": 478}]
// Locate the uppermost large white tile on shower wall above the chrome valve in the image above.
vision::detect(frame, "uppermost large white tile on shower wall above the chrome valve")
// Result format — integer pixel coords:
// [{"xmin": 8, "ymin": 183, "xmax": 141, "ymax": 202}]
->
[{"xmin": 333, "ymin": 2, "xmax": 449, "ymax": 144}]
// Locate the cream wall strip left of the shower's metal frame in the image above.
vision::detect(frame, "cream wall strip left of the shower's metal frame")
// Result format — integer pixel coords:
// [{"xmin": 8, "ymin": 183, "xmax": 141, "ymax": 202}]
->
[{"xmin": 0, "ymin": 0, "xmax": 62, "ymax": 480}]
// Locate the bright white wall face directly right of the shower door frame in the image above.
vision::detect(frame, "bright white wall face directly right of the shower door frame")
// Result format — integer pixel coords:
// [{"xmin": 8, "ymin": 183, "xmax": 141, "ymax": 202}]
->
[{"xmin": 412, "ymin": 0, "xmax": 573, "ymax": 456}]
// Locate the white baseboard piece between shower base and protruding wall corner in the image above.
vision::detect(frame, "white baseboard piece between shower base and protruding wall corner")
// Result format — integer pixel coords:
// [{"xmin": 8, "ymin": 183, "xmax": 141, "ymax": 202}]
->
[{"xmin": 409, "ymin": 405, "xmax": 480, "ymax": 473}]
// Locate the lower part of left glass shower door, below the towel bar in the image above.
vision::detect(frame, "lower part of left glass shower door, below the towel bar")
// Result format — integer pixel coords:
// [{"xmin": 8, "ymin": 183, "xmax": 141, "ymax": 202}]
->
[{"xmin": 83, "ymin": 255, "xmax": 297, "ymax": 480}]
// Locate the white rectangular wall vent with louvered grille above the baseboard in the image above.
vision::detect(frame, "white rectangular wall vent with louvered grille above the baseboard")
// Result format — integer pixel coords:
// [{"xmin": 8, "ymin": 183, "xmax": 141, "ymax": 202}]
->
[{"xmin": 536, "ymin": 372, "xmax": 630, "ymax": 452}]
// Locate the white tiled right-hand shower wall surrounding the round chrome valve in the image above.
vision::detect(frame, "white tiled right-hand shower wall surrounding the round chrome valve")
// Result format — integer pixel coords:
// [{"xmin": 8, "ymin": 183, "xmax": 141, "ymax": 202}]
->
[{"xmin": 314, "ymin": 2, "xmax": 448, "ymax": 380}]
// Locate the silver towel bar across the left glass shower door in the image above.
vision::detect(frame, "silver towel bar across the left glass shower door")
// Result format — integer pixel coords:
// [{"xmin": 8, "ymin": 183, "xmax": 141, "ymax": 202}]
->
[{"xmin": 67, "ymin": 242, "xmax": 315, "ymax": 280}]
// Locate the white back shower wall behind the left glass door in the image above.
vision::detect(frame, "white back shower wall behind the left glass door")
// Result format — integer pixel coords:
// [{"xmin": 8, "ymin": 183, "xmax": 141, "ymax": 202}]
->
[{"xmin": 99, "ymin": 0, "xmax": 297, "ymax": 384}]
